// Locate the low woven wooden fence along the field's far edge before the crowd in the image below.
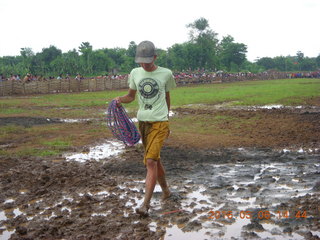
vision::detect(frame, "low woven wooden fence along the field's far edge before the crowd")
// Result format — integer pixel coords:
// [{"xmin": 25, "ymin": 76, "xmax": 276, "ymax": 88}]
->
[{"xmin": 0, "ymin": 72, "xmax": 288, "ymax": 96}]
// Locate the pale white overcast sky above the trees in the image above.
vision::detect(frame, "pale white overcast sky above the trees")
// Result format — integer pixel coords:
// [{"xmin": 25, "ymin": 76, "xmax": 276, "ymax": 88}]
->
[{"xmin": 0, "ymin": 0, "xmax": 320, "ymax": 61}]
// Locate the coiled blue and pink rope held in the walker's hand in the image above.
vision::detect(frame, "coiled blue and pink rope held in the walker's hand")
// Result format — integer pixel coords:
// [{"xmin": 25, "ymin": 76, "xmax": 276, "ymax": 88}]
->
[{"xmin": 107, "ymin": 100, "xmax": 140, "ymax": 146}]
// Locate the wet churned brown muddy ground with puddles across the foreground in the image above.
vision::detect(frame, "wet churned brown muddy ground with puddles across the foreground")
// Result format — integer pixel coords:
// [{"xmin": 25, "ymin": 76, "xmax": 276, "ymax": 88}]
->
[{"xmin": 0, "ymin": 106, "xmax": 320, "ymax": 239}]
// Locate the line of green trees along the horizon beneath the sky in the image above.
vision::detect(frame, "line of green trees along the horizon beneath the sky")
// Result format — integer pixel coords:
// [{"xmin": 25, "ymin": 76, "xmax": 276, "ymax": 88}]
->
[{"xmin": 0, "ymin": 18, "xmax": 320, "ymax": 76}]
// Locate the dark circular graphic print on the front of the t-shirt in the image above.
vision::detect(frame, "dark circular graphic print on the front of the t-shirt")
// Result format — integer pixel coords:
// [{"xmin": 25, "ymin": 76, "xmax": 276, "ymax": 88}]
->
[{"xmin": 138, "ymin": 78, "xmax": 161, "ymax": 110}]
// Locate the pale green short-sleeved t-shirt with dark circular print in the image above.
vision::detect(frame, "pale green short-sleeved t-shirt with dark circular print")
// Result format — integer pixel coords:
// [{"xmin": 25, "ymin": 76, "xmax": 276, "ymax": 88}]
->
[{"xmin": 128, "ymin": 66, "xmax": 176, "ymax": 122}]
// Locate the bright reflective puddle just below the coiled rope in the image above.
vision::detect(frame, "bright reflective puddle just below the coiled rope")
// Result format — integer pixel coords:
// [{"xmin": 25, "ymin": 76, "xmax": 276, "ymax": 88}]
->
[{"xmin": 64, "ymin": 141, "xmax": 125, "ymax": 163}]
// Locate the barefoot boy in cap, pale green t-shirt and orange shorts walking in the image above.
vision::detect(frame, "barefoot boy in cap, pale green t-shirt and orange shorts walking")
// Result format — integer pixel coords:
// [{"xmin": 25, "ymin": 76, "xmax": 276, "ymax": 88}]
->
[{"xmin": 115, "ymin": 41, "xmax": 176, "ymax": 216}]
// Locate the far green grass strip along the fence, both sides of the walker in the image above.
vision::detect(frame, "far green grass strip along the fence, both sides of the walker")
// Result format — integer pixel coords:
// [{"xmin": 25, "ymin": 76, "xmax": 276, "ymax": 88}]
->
[{"xmin": 0, "ymin": 79, "xmax": 320, "ymax": 117}]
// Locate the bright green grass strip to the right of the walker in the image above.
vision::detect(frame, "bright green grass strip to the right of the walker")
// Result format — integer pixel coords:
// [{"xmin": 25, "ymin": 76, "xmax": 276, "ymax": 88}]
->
[{"xmin": 171, "ymin": 79, "xmax": 320, "ymax": 106}]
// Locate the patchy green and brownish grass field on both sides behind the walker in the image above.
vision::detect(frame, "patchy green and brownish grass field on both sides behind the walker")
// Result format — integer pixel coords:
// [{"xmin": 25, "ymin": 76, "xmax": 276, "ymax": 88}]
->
[{"xmin": 0, "ymin": 79, "xmax": 320, "ymax": 157}]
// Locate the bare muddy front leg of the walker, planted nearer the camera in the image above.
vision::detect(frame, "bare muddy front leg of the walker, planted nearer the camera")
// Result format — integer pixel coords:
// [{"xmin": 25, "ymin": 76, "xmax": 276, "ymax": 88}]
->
[{"xmin": 136, "ymin": 159, "xmax": 158, "ymax": 216}]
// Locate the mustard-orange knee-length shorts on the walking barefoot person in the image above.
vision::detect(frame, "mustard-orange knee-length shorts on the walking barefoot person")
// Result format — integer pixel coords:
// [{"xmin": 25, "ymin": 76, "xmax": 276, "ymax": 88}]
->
[{"xmin": 139, "ymin": 121, "xmax": 169, "ymax": 165}]
